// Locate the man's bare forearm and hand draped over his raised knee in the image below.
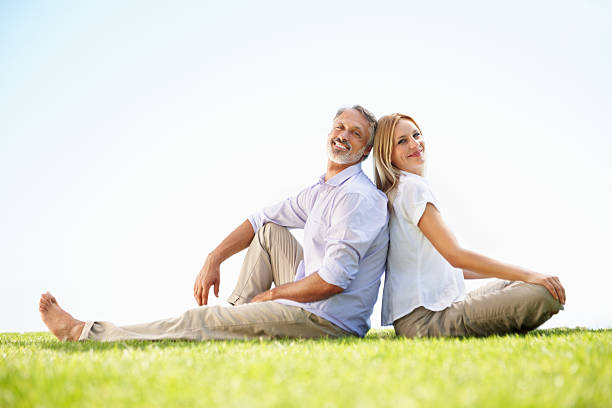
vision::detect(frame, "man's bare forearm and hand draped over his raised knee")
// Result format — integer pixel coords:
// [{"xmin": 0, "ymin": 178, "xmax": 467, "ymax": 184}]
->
[{"xmin": 193, "ymin": 220, "xmax": 255, "ymax": 306}]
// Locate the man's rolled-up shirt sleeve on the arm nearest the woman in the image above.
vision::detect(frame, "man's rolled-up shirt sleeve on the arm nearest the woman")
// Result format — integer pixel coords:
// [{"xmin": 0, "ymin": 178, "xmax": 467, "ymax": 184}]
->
[{"xmin": 318, "ymin": 193, "xmax": 387, "ymax": 289}]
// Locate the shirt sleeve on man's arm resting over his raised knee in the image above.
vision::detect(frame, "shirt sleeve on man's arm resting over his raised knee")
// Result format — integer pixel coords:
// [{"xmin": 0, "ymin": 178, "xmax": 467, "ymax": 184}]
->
[{"xmin": 249, "ymin": 188, "xmax": 310, "ymax": 232}]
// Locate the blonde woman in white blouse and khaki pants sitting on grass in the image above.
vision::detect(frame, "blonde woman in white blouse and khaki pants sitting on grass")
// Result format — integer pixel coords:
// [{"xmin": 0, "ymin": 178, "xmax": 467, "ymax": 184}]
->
[{"xmin": 374, "ymin": 113, "xmax": 565, "ymax": 337}]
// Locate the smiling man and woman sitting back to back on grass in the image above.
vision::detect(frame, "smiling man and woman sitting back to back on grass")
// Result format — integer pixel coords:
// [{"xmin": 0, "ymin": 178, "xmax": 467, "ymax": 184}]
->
[{"xmin": 39, "ymin": 105, "xmax": 565, "ymax": 341}]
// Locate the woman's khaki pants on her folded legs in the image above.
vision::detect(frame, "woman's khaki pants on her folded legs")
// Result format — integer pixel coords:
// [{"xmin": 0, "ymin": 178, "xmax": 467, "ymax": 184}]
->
[{"xmin": 393, "ymin": 280, "xmax": 563, "ymax": 337}]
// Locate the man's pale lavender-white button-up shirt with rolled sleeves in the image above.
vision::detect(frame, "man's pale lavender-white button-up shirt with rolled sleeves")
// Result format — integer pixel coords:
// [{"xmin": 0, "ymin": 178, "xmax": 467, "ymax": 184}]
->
[{"xmin": 249, "ymin": 164, "xmax": 389, "ymax": 336}]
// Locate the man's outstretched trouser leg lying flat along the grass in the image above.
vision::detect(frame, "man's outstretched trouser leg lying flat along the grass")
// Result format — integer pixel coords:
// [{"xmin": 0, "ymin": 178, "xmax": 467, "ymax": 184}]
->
[{"xmin": 79, "ymin": 302, "xmax": 351, "ymax": 341}]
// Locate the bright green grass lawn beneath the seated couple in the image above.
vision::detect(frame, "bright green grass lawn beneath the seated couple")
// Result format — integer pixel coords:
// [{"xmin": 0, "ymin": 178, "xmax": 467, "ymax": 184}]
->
[{"xmin": 0, "ymin": 329, "xmax": 612, "ymax": 408}]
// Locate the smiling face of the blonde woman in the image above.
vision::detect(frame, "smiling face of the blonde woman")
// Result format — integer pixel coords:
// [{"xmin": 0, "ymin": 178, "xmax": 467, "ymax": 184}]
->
[{"xmin": 391, "ymin": 119, "xmax": 425, "ymax": 176}]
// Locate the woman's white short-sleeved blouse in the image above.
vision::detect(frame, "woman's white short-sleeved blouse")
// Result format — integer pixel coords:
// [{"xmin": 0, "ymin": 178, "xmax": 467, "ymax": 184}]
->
[{"xmin": 382, "ymin": 171, "xmax": 465, "ymax": 325}]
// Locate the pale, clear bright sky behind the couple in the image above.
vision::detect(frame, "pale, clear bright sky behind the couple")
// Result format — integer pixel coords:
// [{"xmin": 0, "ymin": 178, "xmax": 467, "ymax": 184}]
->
[{"xmin": 0, "ymin": 0, "xmax": 612, "ymax": 332}]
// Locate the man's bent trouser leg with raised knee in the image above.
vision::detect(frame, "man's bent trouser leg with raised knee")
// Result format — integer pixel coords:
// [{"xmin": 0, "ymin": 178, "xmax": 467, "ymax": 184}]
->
[{"xmin": 227, "ymin": 223, "xmax": 304, "ymax": 305}]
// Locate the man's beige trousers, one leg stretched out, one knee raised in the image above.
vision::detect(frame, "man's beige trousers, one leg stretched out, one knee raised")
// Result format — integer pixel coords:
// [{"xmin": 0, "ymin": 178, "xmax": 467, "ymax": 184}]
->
[{"xmin": 79, "ymin": 223, "xmax": 353, "ymax": 341}]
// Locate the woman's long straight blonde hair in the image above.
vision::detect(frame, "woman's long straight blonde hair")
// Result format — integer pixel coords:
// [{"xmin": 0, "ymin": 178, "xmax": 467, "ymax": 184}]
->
[{"xmin": 373, "ymin": 113, "xmax": 422, "ymax": 209}]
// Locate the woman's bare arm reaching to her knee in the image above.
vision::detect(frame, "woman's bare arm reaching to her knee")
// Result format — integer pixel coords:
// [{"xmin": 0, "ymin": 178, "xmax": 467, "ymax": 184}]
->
[{"xmin": 418, "ymin": 203, "xmax": 565, "ymax": 304}]
